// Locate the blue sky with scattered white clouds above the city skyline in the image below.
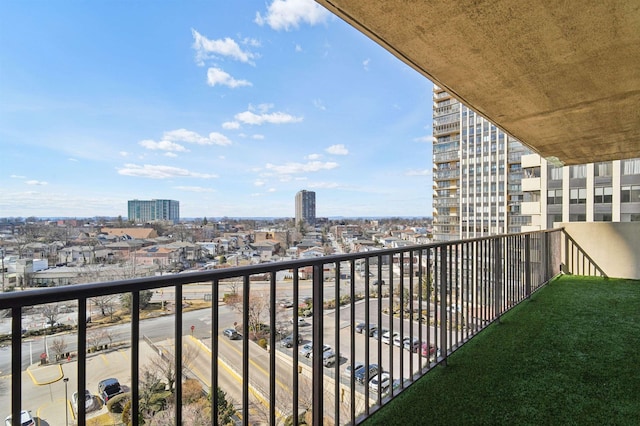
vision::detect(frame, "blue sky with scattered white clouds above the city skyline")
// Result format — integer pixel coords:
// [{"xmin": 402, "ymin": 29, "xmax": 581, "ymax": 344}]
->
[{"xmin": 0, "ymin": 0, "xmax": 432, "ymax": 217}]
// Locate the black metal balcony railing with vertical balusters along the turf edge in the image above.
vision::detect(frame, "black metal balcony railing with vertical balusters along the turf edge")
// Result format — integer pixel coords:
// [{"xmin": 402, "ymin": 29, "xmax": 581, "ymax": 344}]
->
[{"xmin": 0, "ymin": 229, "xmax": 563, "ymax": 425}]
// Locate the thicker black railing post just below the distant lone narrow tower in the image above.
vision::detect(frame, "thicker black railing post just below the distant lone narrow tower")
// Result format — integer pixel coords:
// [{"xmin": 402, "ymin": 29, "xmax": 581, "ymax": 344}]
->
[{"xmin": 311, "ymin": 263, "xmax": 324, "ymax": 425}]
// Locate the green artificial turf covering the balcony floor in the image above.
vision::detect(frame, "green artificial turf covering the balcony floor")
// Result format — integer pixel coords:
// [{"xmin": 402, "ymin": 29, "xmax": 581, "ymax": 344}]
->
[{"xmin": 363, "ymin": 276, "xmax": 640, "ymax": 426}]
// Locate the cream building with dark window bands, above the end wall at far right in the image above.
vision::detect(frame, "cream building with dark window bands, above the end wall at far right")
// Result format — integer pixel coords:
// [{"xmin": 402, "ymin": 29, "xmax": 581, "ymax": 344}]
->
[{"xmin": 522, "ymin": 154, "xmax": 640, "ymax": 231}]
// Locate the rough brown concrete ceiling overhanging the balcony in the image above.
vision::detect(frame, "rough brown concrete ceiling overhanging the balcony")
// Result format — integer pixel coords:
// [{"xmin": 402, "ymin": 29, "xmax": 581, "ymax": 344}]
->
[{"xmin": 316, "ymin": 0, "xmax": 640, "ymax": 165}]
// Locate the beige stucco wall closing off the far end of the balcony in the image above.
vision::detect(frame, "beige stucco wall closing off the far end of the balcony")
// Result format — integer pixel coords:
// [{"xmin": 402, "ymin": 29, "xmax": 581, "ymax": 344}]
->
[{"xmin": 558, "ymin": 222, "xmax": 640, "ymax": 279}]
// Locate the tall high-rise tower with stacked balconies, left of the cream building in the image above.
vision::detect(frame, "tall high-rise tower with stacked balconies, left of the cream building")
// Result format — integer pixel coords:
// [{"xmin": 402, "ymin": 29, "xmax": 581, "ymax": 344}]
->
[{"xmin": 433, "ymin": 86, "xmax": 531, "ymax": 241}]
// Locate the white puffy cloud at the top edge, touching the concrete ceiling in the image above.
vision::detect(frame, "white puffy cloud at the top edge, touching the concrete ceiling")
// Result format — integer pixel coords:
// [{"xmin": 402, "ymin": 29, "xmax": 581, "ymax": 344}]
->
[{"xmin": 255, "ymin": 0, "xmax": 329, "ymax": 31}]
